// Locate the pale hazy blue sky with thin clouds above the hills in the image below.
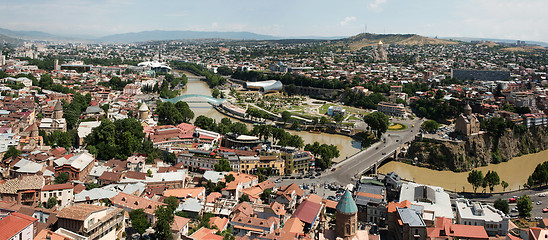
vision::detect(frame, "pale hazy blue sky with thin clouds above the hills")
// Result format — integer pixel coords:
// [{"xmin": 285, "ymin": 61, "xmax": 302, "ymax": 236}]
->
[{"xmin": 0, "ymin": 0, "xmax": 548, "ymax": 42}]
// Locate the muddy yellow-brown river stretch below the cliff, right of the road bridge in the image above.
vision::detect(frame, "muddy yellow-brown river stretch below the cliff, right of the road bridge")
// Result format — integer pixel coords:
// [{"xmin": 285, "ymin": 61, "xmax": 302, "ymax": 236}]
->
[{"xmin": 378, "ymin": 150, "xmax": 548, "ymax": 192}]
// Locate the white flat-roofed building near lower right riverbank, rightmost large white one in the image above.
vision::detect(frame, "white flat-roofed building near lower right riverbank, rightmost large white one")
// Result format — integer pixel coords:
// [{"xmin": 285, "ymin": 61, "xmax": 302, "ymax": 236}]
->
[{"xmin": 456, "ymin": 199, "xmax": 510, "ymax": 236}]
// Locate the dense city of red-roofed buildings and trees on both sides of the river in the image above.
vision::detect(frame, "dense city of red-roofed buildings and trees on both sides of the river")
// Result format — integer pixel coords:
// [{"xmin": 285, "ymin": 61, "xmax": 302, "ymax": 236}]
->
[{"xmin": 0, "ymin": 36, "xmax": 548, "ymax": 240}]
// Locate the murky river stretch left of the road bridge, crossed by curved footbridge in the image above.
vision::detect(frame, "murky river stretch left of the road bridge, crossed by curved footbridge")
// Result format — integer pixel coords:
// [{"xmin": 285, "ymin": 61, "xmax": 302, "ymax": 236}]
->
[{"xmin": 177, "ymin": 72, "xmax": 361, "ymax": 162}]
